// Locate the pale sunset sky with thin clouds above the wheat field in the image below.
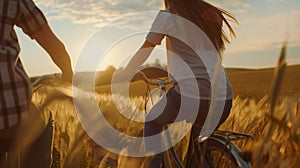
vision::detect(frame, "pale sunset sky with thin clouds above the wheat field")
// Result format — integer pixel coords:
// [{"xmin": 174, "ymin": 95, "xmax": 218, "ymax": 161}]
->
[{"xmin": 16, "ymin": 0, "xmax": 300, "ymax": 76}]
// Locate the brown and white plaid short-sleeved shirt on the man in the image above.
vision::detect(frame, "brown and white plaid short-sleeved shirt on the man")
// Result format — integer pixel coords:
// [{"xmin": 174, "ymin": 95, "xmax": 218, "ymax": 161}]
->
[{"xmin": 0, "ymin": 0, "xmax": 47, "ymax": 129}]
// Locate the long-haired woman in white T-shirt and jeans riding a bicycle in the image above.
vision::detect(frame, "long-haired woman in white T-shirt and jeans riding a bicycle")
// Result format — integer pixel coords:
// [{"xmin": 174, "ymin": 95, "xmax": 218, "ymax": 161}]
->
[{"xmin": 117, "ymin": 0, "xmax": 236, "ymax": 168}]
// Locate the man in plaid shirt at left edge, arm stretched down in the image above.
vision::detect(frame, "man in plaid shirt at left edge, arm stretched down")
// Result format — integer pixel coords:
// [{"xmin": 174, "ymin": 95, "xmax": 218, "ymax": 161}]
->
[{"xmin": 0, "ymin": 0, "xmax": 73, "ymax": 167}]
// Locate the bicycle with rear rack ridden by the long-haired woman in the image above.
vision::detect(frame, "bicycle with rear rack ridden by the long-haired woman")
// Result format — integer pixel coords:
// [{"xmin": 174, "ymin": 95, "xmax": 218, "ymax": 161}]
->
[{"xmin": 132, "ymin": 71, "xmax": 254, "ymax": 168}]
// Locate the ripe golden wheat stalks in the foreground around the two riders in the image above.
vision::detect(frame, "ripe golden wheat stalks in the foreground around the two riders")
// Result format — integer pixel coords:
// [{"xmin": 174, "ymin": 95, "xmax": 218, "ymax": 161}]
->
[{"xmin": 28, "ymin": 76, "xmax": 300, "ymax": 168}]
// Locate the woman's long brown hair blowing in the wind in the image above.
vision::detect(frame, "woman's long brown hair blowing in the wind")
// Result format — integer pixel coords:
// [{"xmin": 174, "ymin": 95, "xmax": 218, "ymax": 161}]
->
[{"xmin": 164, "ymin": 0, "xmax": 238, "ymax": 53}]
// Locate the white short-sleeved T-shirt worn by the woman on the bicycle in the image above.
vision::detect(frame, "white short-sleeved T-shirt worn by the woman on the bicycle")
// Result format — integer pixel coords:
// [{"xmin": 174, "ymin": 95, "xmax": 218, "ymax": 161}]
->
[{"xmin": 146, "ymin": 10, "xmax": 233, "ymax": 100}]
